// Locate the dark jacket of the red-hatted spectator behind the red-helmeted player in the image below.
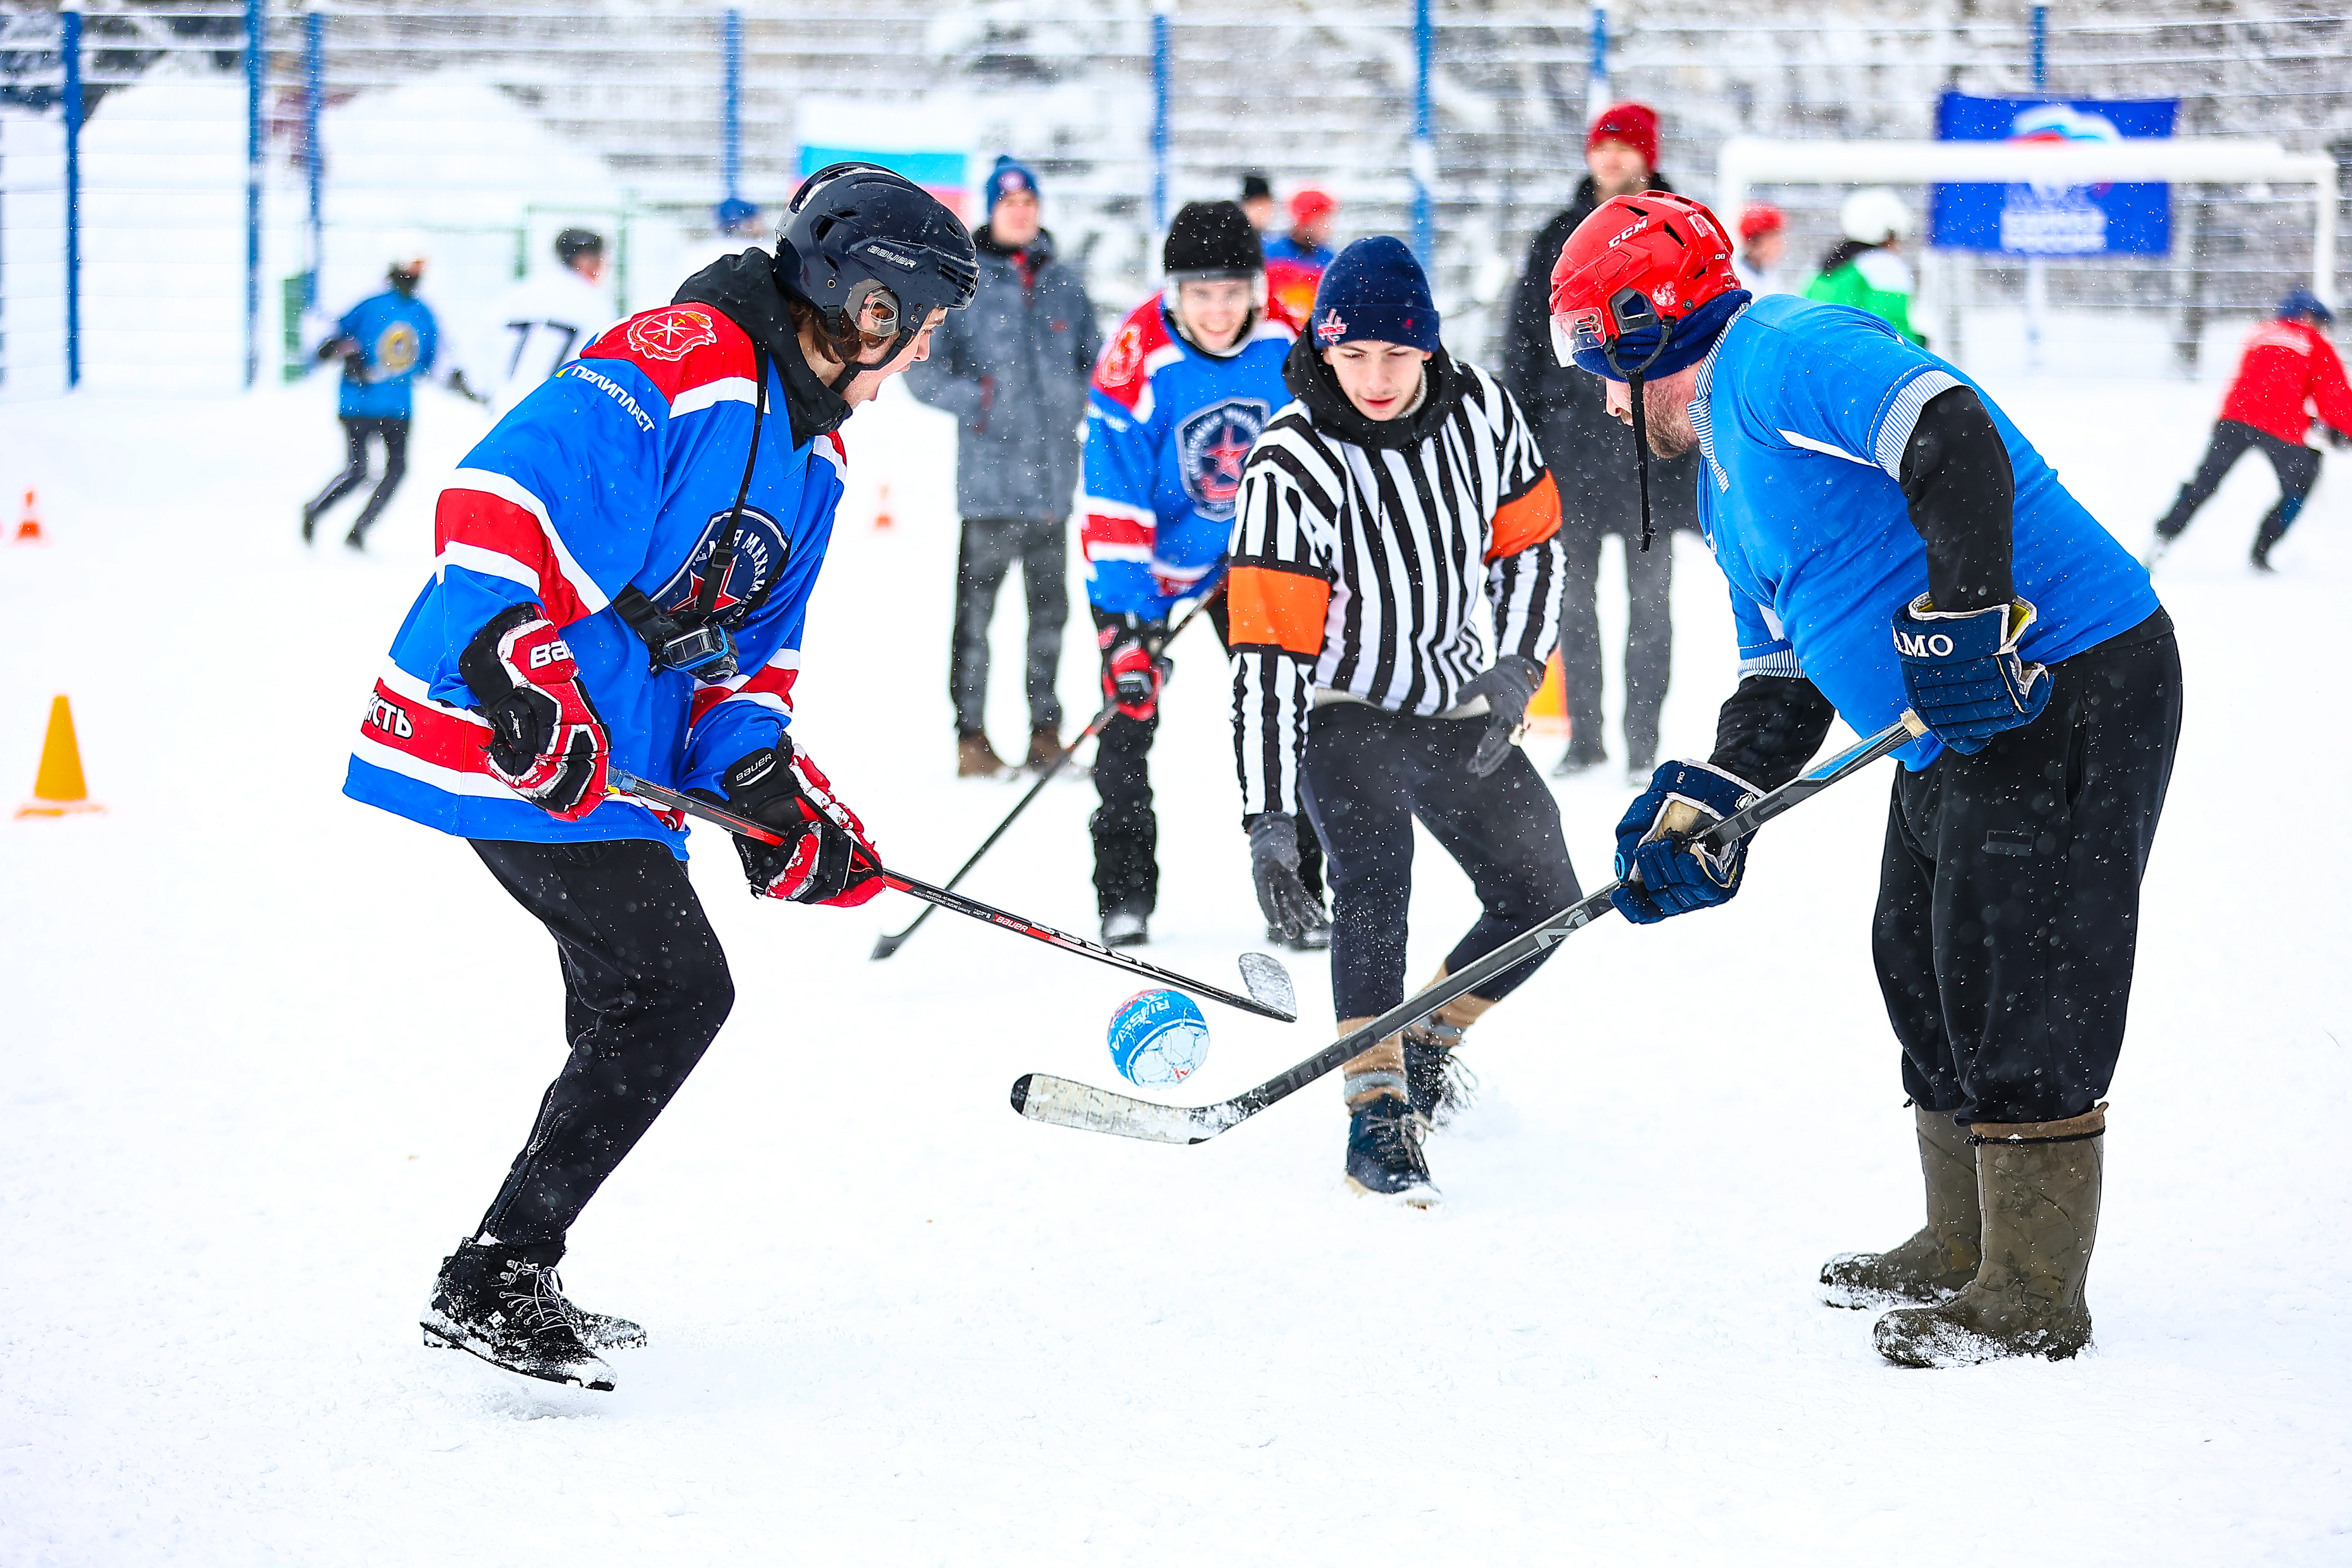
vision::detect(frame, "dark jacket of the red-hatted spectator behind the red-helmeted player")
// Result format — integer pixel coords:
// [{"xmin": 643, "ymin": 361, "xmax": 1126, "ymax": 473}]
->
[{"xmin": 1503, "ymin": 174, "xmax": 1698, "ymax": 539}]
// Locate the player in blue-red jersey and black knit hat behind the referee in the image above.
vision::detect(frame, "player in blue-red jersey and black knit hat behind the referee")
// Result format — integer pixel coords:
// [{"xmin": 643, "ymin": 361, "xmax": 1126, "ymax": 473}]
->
[{"xmin": 1077, "ymin": 202, "xmax": 1331, "ymax": 952}]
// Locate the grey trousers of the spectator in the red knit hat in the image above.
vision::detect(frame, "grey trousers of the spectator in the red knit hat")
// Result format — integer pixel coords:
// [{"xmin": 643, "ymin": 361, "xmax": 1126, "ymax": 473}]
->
[{"xmin": 1559, "ymin": 522, "xmax": 1675, "ymax": 767}]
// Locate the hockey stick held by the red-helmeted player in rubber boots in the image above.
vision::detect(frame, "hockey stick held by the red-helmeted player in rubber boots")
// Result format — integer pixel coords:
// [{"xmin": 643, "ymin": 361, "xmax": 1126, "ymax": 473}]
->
[{"xmin": 1014, "ymin": 713, "xmax": 1926, "ymax": 1142}]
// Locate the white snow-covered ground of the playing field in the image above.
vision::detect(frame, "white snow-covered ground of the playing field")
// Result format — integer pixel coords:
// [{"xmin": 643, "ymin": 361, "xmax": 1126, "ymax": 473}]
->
[{"xmin": 0, "ymin": 350, "xmax": 2352, "ymax": 1568}]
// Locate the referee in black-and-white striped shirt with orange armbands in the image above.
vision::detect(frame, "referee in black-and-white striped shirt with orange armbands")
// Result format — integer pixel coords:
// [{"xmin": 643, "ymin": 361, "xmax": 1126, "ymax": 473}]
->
[{"xmin": 1225, "ymin": 238, "xmax": 1578, "ymax": 1206}]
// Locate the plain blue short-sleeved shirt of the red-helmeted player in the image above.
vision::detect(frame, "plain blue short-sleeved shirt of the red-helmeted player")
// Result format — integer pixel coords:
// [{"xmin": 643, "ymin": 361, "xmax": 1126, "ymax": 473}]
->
[{"xmin": 1691, "ymin": 294, "xmax": 2159, "ymax": 769}]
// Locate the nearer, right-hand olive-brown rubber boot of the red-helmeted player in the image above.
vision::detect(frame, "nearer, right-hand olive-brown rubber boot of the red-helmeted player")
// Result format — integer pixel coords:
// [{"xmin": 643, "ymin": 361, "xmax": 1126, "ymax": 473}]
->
[{"xmin": 1872, "ymin": 1102, "xmax": 2107, "ymax": 1366}]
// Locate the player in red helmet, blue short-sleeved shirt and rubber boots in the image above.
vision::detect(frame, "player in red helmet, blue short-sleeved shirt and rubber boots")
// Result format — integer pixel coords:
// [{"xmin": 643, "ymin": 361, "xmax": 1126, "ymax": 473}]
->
[{"xmin": 1552, "ymin": 195, "xmax": 2180, "ymax": 1366}]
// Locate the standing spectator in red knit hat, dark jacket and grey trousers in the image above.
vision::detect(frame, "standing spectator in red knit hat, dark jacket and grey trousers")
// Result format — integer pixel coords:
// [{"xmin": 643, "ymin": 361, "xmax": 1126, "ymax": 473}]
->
[{"xmin": 1503, "ymin": 103, "xmax": 1698, "ymax": 783}]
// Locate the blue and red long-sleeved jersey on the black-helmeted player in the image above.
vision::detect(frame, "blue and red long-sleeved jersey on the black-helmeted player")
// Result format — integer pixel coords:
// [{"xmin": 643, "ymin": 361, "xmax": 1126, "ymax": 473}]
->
[{"xmin": 343, "ymin": 303, "xmax": 844, "ymax": 858}]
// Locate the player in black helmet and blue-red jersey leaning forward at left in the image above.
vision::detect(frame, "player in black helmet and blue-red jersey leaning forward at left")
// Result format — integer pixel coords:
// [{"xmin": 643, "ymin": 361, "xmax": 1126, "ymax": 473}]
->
[{"xmin": 343, "ymin": 165, "xmax": 976, "ymax": 1389}]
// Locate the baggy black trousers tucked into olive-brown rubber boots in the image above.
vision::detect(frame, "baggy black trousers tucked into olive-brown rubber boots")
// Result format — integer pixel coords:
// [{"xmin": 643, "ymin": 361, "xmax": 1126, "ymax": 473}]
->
[{"xmin": 1872, "ymin": 609, "xmax": 2180, "ymax": 1124}]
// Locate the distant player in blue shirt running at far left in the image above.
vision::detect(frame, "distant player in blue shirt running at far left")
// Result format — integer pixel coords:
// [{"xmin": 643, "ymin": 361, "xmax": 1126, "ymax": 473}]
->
[{"xmin": 301, "ymin": 249, "xmax": 473, "ymax": 550}]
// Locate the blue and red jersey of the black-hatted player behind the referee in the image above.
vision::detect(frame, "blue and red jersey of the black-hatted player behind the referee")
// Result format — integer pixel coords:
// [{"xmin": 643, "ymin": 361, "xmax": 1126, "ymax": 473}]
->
[{"xmin": 1077, "ymin": 294, "xmax": 1298, "ymax": 621}]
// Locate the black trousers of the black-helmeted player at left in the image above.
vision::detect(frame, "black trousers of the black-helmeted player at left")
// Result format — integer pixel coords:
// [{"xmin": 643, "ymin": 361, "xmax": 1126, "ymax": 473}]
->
[{"xmin": 473, "ymin": 839, "xmax": 734, "ymax": 1262}]
